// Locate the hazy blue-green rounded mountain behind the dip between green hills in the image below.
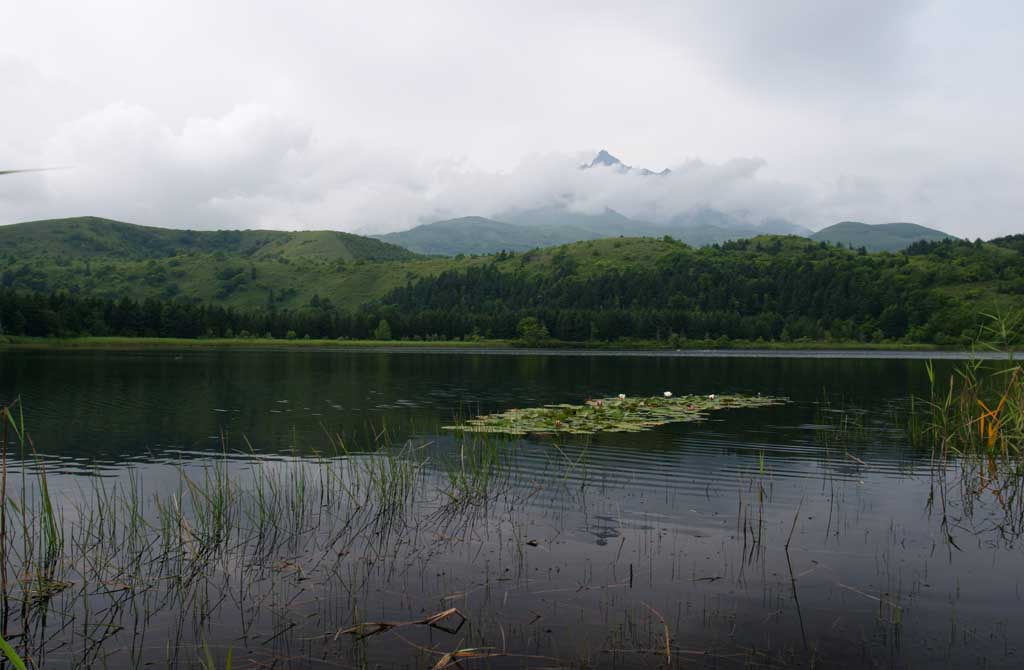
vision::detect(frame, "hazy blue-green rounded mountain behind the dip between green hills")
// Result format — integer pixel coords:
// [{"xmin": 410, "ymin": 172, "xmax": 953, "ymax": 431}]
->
[{"xmin": 376, "ymin": 216, "xmax": 601, "ymax": 256}]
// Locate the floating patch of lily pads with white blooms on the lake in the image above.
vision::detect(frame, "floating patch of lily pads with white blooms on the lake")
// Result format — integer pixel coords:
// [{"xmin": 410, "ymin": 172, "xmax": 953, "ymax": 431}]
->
[{"xmin": 444, "ymin": 391, "xmax": 786, "ymax": 435}]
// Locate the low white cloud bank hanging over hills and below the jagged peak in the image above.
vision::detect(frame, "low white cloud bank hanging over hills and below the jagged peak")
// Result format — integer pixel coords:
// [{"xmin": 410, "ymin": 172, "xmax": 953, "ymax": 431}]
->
[{"xmin": 5, "ymin": 102, "xmax": 808, "ymax": 233}]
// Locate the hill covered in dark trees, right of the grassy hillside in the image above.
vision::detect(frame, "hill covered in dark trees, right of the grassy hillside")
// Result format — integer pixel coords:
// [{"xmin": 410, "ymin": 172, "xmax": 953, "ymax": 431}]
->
[{"xmin": 374, "ymin": 239, "xmax": 1024, "ymax": 344}]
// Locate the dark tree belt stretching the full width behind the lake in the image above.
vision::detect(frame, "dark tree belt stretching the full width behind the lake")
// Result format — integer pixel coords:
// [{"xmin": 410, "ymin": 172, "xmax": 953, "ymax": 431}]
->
[{"xmin": 0, "ymin": 236, "xmax": 1024, "ymax": 344}]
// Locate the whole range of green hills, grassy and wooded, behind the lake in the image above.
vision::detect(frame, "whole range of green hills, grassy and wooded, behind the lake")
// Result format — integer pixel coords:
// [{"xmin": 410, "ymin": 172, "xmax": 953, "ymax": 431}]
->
[{"xmin": 0, "ymin": 219, "xmax": 1024, "ymax": 344}]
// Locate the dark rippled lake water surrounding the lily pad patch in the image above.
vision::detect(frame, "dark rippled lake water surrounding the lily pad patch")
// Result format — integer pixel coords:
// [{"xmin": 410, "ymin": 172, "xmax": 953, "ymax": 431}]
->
[{"xmin": 0, "ymin": 350, "xmax": 1024, "ymax": 668}]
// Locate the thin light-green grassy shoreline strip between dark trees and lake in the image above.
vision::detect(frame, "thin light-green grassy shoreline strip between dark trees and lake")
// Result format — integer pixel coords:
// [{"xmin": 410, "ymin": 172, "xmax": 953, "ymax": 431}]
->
[{"xmin": 0, "ymin": 336, "xmax": 1007, "ymax": 359}]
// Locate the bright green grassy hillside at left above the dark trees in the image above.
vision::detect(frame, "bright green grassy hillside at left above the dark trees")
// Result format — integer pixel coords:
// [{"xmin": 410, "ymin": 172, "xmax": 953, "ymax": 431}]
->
[{"xmin": 0, "ymin": 217, "xmax": 446, "ymax": 308}]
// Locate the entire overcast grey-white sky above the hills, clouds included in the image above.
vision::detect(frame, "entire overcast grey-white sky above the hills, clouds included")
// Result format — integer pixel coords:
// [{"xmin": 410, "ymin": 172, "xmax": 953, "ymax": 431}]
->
[{"xmin": 0, "ymin": 0, "xmax": 1024, "ymax": 239}]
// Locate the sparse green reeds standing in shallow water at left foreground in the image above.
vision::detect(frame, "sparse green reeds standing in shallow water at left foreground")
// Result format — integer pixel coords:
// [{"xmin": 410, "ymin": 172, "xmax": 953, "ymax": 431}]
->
[{"xmin": 0, "ymin": 403, "xmax": 491, "ymax": 667}]
